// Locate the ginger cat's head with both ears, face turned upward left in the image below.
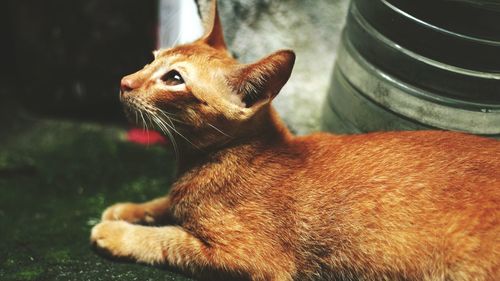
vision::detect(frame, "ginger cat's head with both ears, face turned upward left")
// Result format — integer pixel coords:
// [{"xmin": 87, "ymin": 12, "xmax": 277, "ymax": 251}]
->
[{"xmin": 120, "ymin": 1, "xmax": 295, "ymax": 152}]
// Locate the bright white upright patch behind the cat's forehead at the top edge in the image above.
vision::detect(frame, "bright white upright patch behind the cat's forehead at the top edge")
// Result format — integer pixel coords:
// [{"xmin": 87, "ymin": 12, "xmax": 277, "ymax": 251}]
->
[{"xmin": 158, "ymin": 0, "xmax": 203, "ymax": 48}]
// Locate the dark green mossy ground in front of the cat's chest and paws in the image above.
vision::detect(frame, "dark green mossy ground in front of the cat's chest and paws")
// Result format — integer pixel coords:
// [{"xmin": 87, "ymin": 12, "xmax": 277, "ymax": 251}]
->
[{"xmin": 0, "ymin": 115, "xmax": 190, "ymax": 281}]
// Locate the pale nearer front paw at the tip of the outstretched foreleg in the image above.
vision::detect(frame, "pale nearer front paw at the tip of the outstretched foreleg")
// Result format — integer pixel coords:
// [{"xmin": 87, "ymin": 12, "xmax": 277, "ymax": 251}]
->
[{"xmin": 90, "ymin": 221, "xmax": 131, "ymax": 257}]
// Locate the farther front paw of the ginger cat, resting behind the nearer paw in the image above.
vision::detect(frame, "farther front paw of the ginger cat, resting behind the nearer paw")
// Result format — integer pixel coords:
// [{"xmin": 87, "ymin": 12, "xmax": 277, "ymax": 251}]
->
[{"xmin": 101, "ymin": 203, "xmax": 154, "ymax": 223}]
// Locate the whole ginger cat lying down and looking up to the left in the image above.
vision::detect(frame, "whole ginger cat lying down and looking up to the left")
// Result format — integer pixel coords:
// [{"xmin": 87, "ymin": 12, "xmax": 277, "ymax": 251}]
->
[{"xmin": 91, "ymin": 2, "xmax": 500, "ymax": 281}]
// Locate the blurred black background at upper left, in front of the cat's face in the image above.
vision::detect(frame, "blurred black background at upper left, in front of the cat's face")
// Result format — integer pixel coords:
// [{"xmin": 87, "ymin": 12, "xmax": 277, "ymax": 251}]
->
[{"xmin": 0, "ymin": 0, "xmax": 158, "ymax": 120}]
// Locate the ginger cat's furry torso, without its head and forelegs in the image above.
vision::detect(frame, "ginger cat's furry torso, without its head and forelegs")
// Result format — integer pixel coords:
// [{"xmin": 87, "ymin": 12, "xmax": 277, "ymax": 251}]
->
[{"xmin": 171, "ymin": 117, "xmax": 500, "ymax": 280}]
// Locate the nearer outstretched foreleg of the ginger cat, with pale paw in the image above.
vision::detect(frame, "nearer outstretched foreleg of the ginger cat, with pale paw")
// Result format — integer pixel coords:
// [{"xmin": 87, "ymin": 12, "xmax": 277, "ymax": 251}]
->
[{"xmin": 90, "ymin": 221, "xmax": 291, "ymax": 280}]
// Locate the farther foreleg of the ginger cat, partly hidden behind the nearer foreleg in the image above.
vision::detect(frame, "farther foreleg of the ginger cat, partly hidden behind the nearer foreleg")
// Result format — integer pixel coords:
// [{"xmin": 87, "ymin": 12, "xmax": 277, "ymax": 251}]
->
[{"xmin": 101, "ymin": 196, "xmax": 170, "ymax": 224}]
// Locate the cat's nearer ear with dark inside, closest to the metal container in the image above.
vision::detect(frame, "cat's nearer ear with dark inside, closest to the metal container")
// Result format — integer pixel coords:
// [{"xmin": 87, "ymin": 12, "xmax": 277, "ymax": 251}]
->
[{"xmin": 231, "ymin": 50, "xmax": 295, "ymax": 108}]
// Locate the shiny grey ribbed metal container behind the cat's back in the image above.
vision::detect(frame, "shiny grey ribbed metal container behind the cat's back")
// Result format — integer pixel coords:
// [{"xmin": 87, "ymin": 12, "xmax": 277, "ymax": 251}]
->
[{"xmin": 323, "ymin": 0, "xmax": 500, "ymax": 136}]
